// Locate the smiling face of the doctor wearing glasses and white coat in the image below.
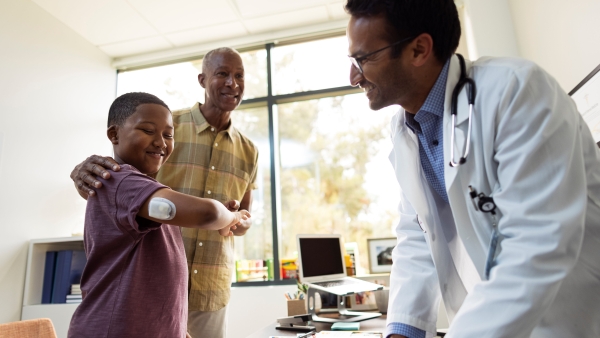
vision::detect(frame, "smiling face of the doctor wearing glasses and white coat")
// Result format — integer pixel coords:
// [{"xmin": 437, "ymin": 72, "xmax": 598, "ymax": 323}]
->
[{"xmin": 347, "ymin": 16, "xmax": 414, "ymax": 110}]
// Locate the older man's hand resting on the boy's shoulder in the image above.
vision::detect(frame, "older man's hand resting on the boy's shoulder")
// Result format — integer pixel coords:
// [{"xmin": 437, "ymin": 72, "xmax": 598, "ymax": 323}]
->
[{"xmin": 71, "ymin": 155, "xmax": 121, "ymax": 199}]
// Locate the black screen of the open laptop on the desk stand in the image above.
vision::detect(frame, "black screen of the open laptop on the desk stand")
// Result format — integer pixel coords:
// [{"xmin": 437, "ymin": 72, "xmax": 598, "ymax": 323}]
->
[{"xmin": 298, "ymin": 237, "xmax": 344, "ymax": 277}]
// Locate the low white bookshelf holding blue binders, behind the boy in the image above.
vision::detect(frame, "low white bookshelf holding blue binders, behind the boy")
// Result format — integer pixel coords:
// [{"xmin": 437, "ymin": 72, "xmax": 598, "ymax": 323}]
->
[{"xmin": 21, "ymin": 236, "xmax": 83, "ymax": 338}]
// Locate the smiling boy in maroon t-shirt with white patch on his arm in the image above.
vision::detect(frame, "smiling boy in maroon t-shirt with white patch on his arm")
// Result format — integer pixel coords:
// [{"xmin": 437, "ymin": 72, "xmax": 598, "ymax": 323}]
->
[{"xmin": 68, "ymin": 93, "xmax": 250, "ymax": 338}]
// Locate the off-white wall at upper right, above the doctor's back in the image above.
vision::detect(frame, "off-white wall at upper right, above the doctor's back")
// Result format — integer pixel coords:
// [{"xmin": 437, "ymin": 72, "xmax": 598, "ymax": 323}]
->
[{"xmin": 463, "ymin": 0, "xmax": 600, "ymax": 92}]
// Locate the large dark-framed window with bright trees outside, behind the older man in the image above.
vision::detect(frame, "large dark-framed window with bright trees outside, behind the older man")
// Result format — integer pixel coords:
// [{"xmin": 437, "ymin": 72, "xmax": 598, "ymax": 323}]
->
[{"xmin": 118, "ymin": 36, "xmax": 399, "ymax": 285}]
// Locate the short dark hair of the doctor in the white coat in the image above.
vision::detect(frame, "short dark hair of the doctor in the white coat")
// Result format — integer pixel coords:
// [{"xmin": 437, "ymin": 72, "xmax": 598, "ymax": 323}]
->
[{"xmin": 344, "ymin": 0, "xmax": 460, "ymax": 63}]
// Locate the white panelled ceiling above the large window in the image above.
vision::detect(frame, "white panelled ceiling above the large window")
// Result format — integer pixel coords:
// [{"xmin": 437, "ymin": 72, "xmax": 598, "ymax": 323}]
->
[{"xmin": 32, "ymin": 0, "xmax": 348, "ymax": 58}]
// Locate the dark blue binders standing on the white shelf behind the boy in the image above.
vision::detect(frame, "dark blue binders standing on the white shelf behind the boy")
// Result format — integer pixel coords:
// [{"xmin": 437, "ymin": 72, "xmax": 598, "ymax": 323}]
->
[{"xmin": 42, "ymin": 250, "xmax": 87, "ymax": 304}]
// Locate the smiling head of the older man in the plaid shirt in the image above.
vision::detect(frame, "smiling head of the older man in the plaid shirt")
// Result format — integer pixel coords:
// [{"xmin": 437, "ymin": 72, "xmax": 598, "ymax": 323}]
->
[{"xmin": 199, "ymin": 52, "xmax": 244, "ymax": 111}]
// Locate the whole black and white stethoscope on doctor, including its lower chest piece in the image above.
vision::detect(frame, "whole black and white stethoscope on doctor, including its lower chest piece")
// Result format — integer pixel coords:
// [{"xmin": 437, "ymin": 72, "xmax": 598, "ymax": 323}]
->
[{"xmin": 450, "ymin": 54, "xmax": 500, "ymax": 280}]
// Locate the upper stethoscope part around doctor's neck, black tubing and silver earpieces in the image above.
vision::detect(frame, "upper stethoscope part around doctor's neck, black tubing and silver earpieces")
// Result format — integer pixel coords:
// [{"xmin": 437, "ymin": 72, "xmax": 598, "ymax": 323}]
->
[{"xmin": 450, "ymin": 54, "xmax": 477, "ymax": 167}]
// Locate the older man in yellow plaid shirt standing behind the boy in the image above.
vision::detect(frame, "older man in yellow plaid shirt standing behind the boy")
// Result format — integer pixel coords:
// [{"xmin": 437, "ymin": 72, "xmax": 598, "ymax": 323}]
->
[{"xmin": 71, "ymin": 48, "xmax": 258, "ymax": 338}]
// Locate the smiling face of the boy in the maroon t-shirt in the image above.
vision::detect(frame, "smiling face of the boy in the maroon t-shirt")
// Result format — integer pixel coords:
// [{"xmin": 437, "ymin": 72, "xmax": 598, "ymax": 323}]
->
[{"xmin": 107, "ymin": 103, "xmax": 174, "ymax": 174}]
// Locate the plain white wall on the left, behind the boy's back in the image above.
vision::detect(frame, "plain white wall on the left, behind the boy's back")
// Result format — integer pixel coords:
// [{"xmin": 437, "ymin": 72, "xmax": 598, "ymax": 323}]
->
[{"xmin": 0, "ymin": 0, "xmax": 116, "ymax": 323}]
